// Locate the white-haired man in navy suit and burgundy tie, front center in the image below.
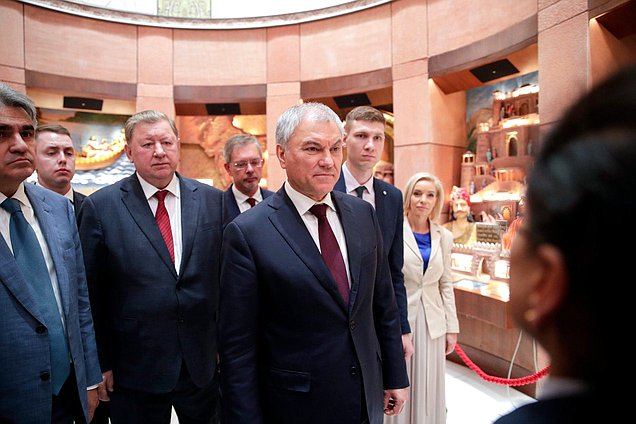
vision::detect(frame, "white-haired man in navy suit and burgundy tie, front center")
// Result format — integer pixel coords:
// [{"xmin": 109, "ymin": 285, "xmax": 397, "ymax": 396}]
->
[{"xmin": 220, "ymin": 103, "xmax": 408, "ymax": 424}]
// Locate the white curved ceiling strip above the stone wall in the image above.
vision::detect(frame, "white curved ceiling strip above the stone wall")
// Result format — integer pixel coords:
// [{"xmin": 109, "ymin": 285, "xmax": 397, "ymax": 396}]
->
[{"xmin": 19, "ymin": 0, "xmax": 393, "ymax": 29}]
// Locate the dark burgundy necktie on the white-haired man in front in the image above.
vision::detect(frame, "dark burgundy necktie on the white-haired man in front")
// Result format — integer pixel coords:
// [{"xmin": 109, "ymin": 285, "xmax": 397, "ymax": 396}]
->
[{"xmin": 309, "ymin": 204, "xmax": 349, "ymax": 304}]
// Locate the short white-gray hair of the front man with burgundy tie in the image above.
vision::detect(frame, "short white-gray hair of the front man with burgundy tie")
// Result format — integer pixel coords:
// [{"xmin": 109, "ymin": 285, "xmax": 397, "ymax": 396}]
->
[{"xmin": 276, "ymin": 102, "xmax": 344, "ymax": 150}]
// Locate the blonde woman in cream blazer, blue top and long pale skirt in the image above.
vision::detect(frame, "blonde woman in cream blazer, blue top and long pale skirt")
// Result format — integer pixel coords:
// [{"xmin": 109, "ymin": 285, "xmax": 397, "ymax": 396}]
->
[{"xmin": 384, "ymin": 172, "xmax": 459, "ymax": 424}]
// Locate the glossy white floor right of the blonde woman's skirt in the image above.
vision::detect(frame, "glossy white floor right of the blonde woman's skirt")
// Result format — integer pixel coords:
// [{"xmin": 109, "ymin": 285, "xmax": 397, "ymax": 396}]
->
[{"xmin": 171, "ymin": 361, "xmax": 534, "ymax": 424}]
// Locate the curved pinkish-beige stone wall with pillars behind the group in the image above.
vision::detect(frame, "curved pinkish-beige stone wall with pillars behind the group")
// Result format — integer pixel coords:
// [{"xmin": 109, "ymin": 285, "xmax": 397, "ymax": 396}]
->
[{"xmin": 0, "ymin": 0, "xmax": 636, "ymax": 190}]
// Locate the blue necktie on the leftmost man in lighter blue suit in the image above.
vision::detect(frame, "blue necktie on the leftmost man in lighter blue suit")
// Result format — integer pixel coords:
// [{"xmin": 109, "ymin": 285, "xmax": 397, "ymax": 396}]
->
[{"xmin": 0, "ymin": 199, "xmax": 71, "ymax": 395}]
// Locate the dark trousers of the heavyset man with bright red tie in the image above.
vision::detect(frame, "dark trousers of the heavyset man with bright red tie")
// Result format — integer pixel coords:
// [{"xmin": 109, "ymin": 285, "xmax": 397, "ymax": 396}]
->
[{"xmin": 110, "ymin": 363, "xmax": 219, "ymax": 424}]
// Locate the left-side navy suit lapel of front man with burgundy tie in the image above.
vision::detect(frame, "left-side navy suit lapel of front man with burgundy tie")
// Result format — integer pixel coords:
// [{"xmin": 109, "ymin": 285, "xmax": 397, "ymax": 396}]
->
[{"xmin": 269, "ymin": 187, "xmax": 347, "ymax": 312}]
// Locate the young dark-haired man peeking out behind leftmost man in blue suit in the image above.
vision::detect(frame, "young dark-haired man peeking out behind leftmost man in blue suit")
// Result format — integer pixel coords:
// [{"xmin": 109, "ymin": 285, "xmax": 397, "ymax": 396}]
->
[{"xmin": 35, "ymin": 124, "xmax": 86, "ymax": 216}]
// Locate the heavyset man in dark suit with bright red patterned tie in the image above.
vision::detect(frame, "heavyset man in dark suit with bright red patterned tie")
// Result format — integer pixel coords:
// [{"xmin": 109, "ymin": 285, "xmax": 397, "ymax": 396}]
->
[{"xmin": 79, "ymin": 111, "xmax": 223, "ymax": 424}]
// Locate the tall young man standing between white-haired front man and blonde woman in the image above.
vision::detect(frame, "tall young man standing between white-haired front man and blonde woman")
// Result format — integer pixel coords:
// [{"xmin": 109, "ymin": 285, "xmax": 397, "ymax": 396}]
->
[{"xmin": 335, "ymin": 106, "xmax": 413, "ymax": 361}]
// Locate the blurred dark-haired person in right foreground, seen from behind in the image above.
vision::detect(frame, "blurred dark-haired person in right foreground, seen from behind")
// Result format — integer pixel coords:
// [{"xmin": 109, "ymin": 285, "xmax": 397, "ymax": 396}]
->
[{"xmin": 496, "ymin": 65, "xmax": 636, "ymax": 424}]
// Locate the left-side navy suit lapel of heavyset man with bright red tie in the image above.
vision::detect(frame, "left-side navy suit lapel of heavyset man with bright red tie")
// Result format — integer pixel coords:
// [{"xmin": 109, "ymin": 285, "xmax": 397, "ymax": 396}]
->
[{"xmin": 121, "ymin": 174, "xmax": 177, "ymax": 278}]
